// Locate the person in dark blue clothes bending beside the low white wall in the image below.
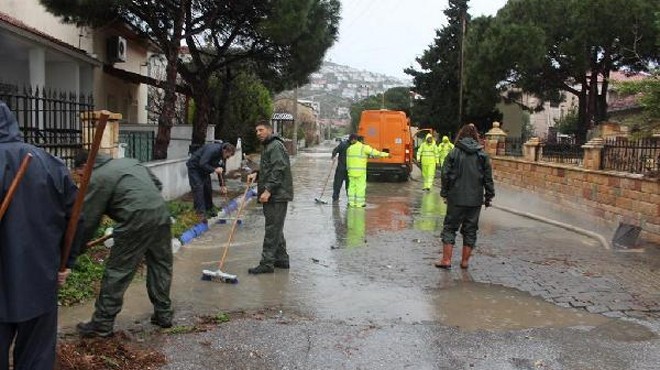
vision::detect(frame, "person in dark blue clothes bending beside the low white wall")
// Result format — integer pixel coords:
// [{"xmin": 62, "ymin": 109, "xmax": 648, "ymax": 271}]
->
[{"xmin": 186, "ymin": 142, "xmax": 236, "ymax": 219}]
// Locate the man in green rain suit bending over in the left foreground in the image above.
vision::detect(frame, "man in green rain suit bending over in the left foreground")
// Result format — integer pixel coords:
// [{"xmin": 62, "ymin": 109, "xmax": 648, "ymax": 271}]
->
[{"xmin": 75, "ymin": 152, "xmax": 172, "ymax": 337}]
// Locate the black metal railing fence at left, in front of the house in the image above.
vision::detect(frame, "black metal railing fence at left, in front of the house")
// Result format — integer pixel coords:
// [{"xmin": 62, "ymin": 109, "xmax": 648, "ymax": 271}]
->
[{"xmin": 0, "ymin": 85, "xmax": 94, "ymax": 166}]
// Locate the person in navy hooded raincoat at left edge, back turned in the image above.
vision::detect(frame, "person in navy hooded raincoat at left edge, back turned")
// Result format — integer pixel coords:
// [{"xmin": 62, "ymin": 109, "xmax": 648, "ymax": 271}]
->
[{"xmin": 0, "ymin": 101, "xmax": 80, "ymax": 370}]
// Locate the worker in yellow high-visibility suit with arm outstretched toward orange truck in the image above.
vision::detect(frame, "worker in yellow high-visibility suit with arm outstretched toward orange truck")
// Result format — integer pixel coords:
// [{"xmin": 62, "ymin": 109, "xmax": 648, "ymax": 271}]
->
[{"xmin": 346, "ymin": 134, "xmax": 390, "ymax": 207}]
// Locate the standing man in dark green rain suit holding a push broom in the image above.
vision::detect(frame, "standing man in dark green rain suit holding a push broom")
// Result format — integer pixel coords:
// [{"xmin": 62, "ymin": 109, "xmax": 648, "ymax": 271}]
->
[{"xmin": 248, "ymin": 121, "xmax": 293, "ymax": 274}]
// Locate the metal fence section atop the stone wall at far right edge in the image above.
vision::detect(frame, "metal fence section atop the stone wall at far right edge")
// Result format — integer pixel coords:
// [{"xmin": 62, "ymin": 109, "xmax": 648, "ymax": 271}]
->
[{"xmin": 601, "ymin": 138, "xmax": 660, "ymax": 174}]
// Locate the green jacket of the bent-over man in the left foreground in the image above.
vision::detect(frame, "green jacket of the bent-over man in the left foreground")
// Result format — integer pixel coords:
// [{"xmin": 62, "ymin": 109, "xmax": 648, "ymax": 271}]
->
[{"xmin": 83, "ymin": 154, "xmax": 170, "ymax": 240}]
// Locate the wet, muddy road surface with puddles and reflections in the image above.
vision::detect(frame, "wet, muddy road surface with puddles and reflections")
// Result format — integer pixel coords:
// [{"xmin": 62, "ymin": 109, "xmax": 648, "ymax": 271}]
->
[{"xmin": 60, "ymin": 146, "xmax": 660, "ymax": 369}]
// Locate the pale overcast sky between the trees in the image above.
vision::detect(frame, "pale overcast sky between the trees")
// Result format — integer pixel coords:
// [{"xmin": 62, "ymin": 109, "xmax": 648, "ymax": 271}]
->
[{"xmin": 326, "ymin": 0, "xmax": 506, "ymax": 78}]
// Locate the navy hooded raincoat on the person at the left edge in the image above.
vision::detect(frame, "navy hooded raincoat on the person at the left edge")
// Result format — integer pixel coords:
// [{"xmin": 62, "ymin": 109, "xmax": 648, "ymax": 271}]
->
[{"xmin": 0, "ymin": 102, "xmax": 78, "ymax": 322}]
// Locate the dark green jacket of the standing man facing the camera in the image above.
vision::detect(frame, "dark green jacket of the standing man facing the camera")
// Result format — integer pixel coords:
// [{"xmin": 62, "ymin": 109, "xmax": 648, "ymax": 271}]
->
[{"xmin": 257, "ymin": 135, "xmax": 293, "ymax": 202}]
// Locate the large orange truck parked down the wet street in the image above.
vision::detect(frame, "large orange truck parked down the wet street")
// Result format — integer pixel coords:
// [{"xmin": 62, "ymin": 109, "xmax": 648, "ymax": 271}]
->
[{"xmin": 357, "ymin": 109, "xmax": 413, "ymax": 181}]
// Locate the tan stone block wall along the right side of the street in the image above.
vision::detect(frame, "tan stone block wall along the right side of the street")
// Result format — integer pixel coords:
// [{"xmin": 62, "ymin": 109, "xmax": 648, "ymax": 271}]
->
[{"xmin": 492, "ymin": 156, "xmax": 660, "ymax": 243}]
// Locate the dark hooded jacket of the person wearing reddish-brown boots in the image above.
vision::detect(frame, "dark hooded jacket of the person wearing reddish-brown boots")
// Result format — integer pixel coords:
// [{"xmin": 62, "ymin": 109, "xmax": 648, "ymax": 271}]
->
[{"xmin": 440, "ymin": 138, "xmax": 495, "ymax": 207}]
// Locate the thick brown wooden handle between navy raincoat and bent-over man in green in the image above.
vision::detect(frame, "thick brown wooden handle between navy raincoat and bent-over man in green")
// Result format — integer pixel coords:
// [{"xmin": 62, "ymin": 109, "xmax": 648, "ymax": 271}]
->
[{"xmin": 60, "ymin": 111, "xmax": 110, "ymax": 272}]
